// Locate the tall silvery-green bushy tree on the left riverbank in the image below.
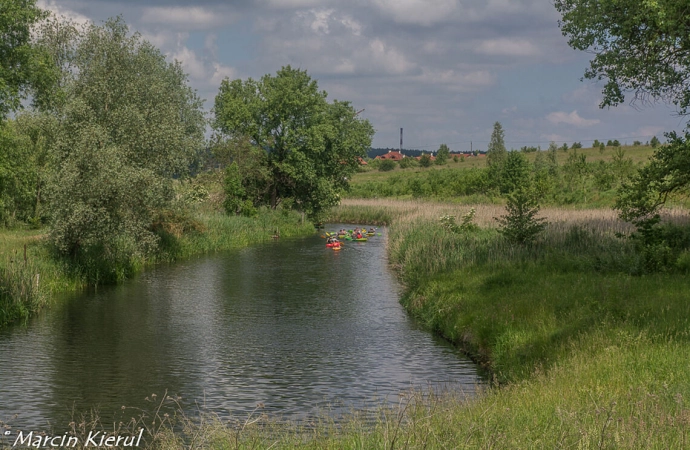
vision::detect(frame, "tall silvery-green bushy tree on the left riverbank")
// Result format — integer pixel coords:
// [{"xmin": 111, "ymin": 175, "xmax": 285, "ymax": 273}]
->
[{"xmin": 43, "ymin": 18, "xmax": 205, "ymax": 278}]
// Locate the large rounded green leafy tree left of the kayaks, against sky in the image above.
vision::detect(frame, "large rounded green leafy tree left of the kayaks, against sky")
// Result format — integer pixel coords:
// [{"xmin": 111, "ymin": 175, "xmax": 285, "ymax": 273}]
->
[{"xmin": 214, "ymin": 66, "xmax": 374, "ymax": 218}]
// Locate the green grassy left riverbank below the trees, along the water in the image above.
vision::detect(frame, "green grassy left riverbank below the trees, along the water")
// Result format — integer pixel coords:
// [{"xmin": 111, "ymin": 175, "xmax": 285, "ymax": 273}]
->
[{"xmin": 0, "ymin": 208, "xmax": 314, "ymax": 328}]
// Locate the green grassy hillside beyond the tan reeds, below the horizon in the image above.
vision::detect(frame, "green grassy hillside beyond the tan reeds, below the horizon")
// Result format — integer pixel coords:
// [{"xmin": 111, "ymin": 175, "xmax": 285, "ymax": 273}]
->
[{"xmin": 347, "ymin": 146, "xmax": 668, "ymax": 208}]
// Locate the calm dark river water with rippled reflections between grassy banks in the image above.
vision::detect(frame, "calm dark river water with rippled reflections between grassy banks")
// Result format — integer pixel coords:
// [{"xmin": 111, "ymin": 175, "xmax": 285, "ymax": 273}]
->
[{"xmin": 0, "ymin": 225, "xmax": 481, "ymax": 432}]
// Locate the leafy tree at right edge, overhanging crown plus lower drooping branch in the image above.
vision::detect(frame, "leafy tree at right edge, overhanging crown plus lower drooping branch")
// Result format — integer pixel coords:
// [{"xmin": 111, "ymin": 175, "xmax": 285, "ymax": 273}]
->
[{"xmin": 555, "ymin": 0, "xmax": 690, "ymax": 224}]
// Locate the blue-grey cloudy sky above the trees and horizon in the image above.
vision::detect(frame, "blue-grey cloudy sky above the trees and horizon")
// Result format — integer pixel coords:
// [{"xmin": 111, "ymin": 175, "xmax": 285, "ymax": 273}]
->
[{"xmin": 39, "ymin": 0, "xmax": 684, "ymax": 151}]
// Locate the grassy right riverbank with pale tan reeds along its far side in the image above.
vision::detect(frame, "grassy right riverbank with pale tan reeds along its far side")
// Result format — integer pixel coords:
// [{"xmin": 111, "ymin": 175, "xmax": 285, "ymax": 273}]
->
[{"xmin": 318, "ymin": 200, "xmax": 690, "ymax": 448}]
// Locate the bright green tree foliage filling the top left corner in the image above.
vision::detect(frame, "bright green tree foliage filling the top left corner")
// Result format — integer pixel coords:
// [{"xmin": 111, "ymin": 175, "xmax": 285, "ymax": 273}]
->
[{"xmin": 0, "ymin": 0, "xmax": 56, "ymax": 121}]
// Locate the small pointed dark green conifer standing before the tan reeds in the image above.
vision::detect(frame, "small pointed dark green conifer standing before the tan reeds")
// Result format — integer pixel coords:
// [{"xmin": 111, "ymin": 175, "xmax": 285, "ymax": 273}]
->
[{"xmin": 496, "ymin": 186, "xmax": 546, "ymax": 245}]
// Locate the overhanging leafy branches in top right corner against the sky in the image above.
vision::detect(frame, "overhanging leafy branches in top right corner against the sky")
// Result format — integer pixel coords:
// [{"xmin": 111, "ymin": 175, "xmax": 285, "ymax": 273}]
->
[{"xmin": 555, "ymin": 0, "xmax": 690, "ymax": 114}]
